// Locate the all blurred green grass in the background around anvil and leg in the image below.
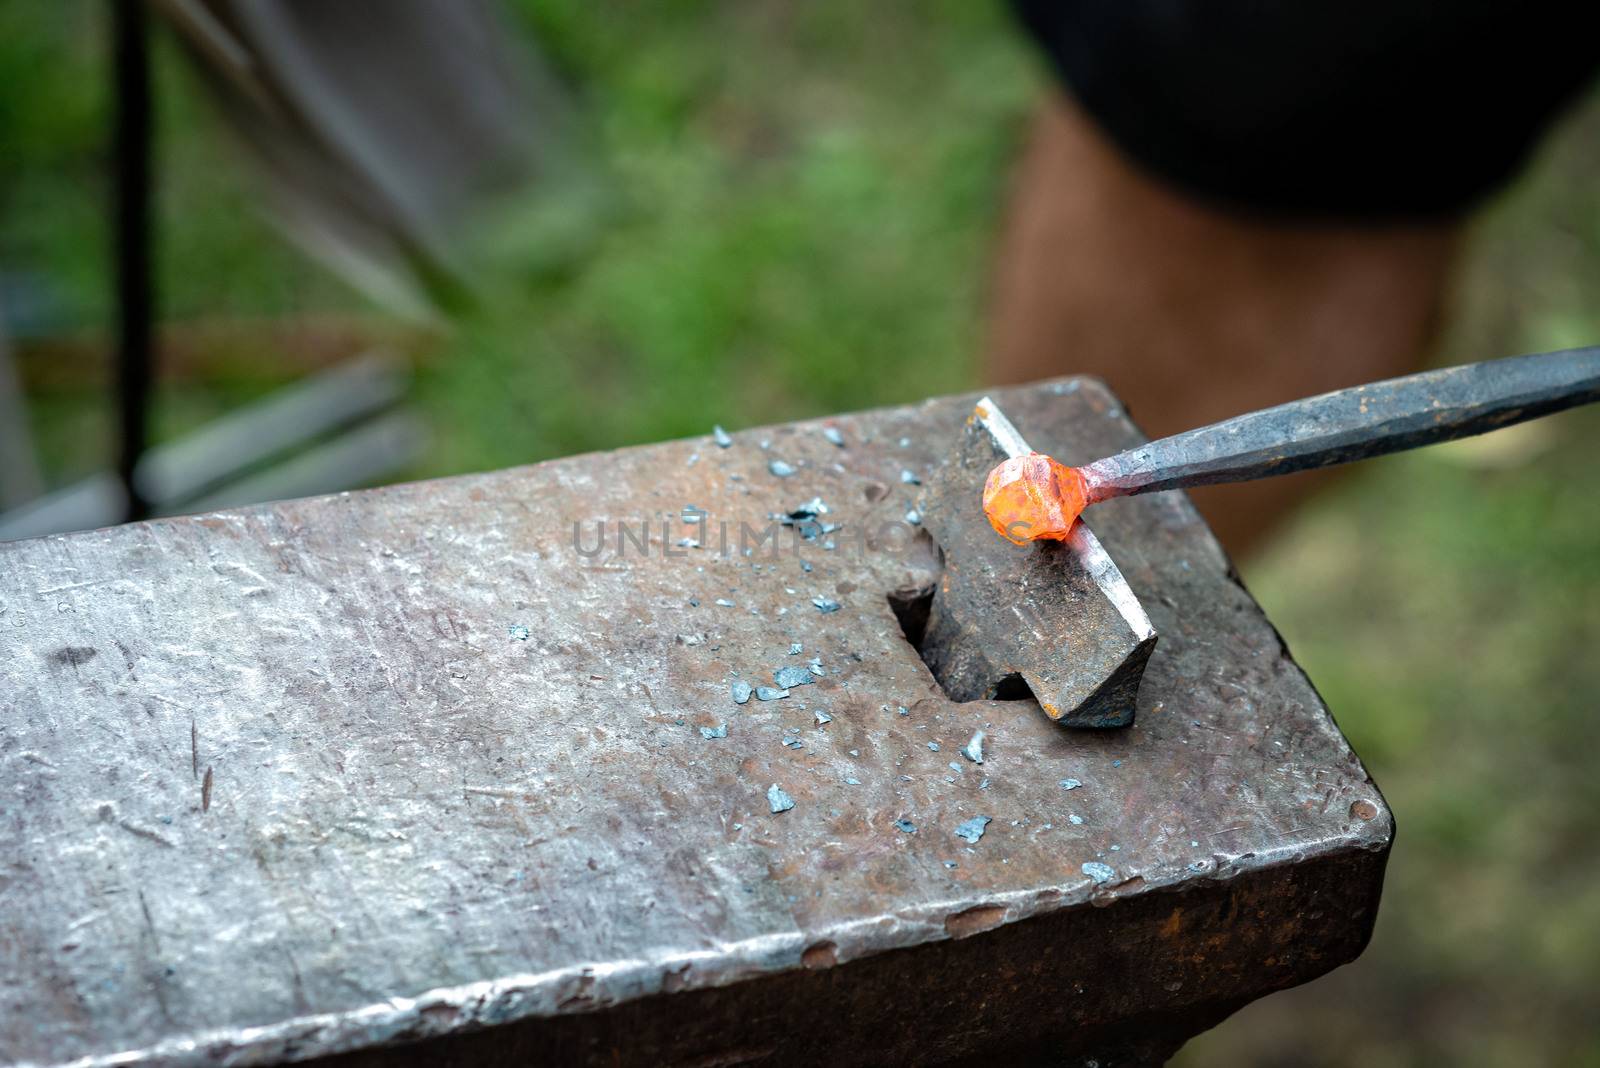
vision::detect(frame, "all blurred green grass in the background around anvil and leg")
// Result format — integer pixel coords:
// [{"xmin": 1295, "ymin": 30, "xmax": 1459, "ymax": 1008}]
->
[{"xmin": 0, "ymin": 0, "xmax": 1600, "ymax": 1065}]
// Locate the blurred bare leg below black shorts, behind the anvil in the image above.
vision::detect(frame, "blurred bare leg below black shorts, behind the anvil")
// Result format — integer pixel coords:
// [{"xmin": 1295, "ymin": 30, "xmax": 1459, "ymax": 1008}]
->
[{"xmin": 987, "ymin": 93, "xmax": 1459, "ymax": 553}]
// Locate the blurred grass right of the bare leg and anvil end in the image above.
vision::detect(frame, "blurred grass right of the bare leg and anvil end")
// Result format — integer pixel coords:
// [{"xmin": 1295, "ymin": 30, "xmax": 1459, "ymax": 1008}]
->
[{"xmin": 1181, "ymin": 93, "xmax": 1600, "ymax": 1068}]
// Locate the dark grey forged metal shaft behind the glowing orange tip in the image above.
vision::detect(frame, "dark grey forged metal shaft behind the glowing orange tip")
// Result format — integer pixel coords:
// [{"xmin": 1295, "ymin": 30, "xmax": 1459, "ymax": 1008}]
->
[{"xmin": 1080, "ymin": 347, "xmax": 1600, "ymax": 502}]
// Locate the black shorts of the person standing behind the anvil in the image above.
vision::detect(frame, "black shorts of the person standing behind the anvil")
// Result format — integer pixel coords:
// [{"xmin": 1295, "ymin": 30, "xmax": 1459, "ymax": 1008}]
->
[{"xmin": 1013, "ymin": 0, "xmax": 1600, "ymax": 219}]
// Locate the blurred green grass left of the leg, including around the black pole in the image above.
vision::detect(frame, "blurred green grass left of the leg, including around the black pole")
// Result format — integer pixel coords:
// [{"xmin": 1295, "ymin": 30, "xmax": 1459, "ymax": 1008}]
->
[{"xmin": 0, "ymin": 0, "xmax": 1038, "ymax": 478}]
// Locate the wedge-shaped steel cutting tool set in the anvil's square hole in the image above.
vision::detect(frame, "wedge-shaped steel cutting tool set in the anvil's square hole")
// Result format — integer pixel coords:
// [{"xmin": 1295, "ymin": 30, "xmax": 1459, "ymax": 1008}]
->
[{"xmin": 920, "ymin": 397, "xmax": 1155, "ymax": 727}]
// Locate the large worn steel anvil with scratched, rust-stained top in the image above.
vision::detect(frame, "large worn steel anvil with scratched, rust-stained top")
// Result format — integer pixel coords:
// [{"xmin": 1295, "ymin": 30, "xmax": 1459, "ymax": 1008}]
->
[{"xmin": 0, "ymin": 381, "xmax": 1392, "ymax": 1065}]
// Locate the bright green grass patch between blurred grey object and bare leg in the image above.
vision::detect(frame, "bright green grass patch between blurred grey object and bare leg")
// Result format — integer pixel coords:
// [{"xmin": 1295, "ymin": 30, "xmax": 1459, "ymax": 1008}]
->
[{"xmin": 419, "ymin": 3, "xmax": 1034, "ymax": 470}]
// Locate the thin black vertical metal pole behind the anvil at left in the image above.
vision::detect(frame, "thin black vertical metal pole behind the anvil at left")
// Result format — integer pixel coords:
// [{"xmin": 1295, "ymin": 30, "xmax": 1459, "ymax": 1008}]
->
[{"xmin": 109, "ymin": 0, "xmax": 155, "ymax": 521}]
